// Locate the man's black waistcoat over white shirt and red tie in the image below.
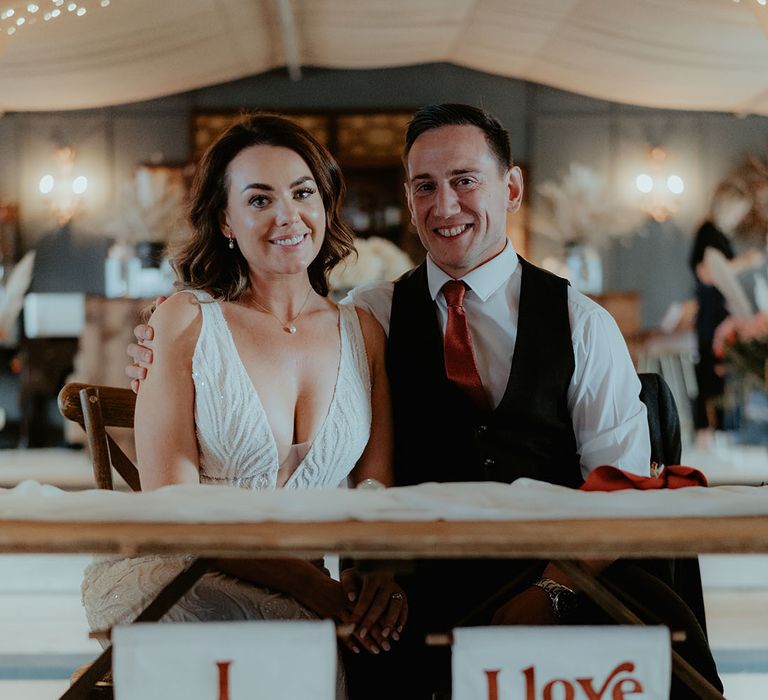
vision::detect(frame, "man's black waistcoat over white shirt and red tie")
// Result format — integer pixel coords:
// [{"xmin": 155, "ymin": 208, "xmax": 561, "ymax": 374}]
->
[{"xmin": 387, "ymin": 258, "xmax": 581, "ymax": 487}]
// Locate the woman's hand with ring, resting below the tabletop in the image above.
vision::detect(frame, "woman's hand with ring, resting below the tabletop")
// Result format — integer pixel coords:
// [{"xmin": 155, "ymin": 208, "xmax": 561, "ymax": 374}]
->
[{"xmin": 340, "ymin": 569, "xmax": 408, "ymax": 651}]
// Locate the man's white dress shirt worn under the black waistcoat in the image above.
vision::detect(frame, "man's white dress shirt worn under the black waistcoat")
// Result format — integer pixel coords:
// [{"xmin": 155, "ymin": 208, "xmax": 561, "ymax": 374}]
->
[{"xmin": 344, "ymin": 242, "xmax": 651, "ymax": 477}]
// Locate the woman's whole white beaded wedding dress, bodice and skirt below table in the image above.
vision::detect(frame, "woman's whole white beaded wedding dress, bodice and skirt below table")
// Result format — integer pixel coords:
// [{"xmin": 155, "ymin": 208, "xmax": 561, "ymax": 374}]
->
[{"xmin": 82, "ymin": 292, "xmax": 371, "ymax": 696}]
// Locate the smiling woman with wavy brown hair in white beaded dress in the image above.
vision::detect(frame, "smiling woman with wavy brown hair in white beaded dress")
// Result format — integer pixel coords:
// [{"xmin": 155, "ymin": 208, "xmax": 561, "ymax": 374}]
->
[{"xmin": 83, "ymin": 114, "xmax": 407, "ymax": 688}]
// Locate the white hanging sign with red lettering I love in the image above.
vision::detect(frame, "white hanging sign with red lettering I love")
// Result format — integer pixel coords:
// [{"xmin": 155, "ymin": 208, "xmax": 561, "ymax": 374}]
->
[{"xmin": 452, "ymin": 626, "xmax": 672, "ymax": 700}]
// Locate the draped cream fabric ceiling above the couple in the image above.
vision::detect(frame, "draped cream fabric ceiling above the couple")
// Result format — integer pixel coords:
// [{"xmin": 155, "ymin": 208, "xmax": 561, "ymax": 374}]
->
[{"xmin": 0, "ymin": 0, "xmax": 768, "ymax": 115}]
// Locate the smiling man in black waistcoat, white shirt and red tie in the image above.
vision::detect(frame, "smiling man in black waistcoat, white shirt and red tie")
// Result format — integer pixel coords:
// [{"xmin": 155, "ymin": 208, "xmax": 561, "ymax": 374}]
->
[{"xmin": 129, "ymin": 104, "xmax": 717, "ymax": 698}]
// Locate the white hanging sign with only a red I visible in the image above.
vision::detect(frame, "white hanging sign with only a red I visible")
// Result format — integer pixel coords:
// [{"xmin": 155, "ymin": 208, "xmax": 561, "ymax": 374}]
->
[{"xmin": 112, "ymin": 621, "xmax": 336, "ymax": 700}]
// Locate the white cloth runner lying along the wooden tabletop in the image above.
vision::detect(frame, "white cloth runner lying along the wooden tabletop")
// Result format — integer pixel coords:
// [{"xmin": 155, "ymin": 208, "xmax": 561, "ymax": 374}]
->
[{"xmin": 0, "ymin": 479, "xmax": 768, "ymax": 523}]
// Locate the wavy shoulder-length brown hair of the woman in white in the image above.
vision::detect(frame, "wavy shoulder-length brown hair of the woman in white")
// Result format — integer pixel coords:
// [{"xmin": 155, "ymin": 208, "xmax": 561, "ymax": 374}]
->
[{"xmin": 173, "ymin": 112, "xmax": 354, "ymax": 301}]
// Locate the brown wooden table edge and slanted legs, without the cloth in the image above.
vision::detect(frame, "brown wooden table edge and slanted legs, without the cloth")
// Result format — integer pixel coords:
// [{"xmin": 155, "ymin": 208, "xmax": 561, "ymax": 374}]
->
[{"xmin": 6, "ymin": 516, "xmax": 768, "ymax": 700}]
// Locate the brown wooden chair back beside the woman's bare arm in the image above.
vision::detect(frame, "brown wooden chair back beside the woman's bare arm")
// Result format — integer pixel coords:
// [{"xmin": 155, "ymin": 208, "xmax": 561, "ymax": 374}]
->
[{"xmin": 59, "ymin": 383, "xmax": 141, "ymax": 491}]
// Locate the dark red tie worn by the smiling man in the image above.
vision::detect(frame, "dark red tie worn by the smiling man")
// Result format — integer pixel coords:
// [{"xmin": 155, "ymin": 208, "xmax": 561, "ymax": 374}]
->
[{"xmin": 442, "ymin": 280, "xmax": 489, "ymax": 409}]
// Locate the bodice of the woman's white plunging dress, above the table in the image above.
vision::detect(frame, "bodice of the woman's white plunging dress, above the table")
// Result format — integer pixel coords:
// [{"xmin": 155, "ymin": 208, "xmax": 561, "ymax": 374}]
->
[{"xmin": 192, "ymin": 293, "xmax": 371, "ymax": 489}]
